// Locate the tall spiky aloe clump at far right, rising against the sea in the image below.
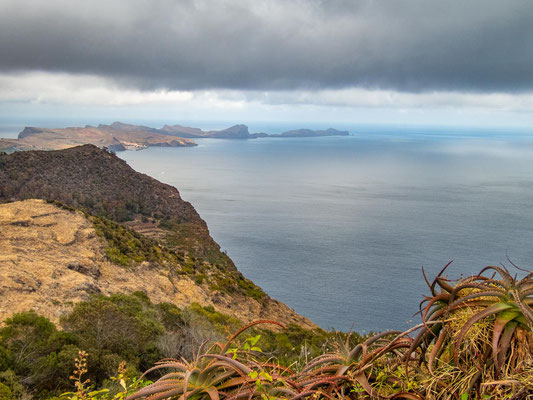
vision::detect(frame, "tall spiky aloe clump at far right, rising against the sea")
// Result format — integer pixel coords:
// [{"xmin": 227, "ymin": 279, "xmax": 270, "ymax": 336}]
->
[{"xmin": 411, "ymin": 264, "xmax": 533, "ymax": 395}]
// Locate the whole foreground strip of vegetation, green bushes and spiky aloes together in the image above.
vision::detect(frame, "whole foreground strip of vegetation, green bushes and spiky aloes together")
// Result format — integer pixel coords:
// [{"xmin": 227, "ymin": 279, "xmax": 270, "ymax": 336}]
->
[{"xmin": 0, "ymin": 266, "xmax": 533, "ymax": 400}]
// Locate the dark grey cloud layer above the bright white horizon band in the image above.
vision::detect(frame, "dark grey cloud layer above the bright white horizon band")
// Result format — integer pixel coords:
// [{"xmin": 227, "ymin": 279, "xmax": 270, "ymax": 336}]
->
[{"xmin": 0, "ymin": 0, "xmax": 533, "ymax": 92}]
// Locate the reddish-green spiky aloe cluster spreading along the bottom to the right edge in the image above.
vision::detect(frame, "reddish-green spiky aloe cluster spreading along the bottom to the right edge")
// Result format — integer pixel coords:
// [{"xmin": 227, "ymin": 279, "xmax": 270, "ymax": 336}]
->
[{"xmin": 128, "ymin": 266, "xmax": 533, "ymax": 400}]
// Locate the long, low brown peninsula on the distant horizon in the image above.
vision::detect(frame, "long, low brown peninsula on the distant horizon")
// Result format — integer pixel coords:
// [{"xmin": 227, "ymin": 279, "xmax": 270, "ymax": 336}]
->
[{"xmin": 0, "ymin": 122, "xmax": 349, "ymax": 151}]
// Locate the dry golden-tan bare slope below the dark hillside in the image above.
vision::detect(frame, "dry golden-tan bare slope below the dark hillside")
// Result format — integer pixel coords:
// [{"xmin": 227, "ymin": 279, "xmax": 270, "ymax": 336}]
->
[{"xmin": 0, "ymin": 200, "xmax": 312, "ymax": 327}]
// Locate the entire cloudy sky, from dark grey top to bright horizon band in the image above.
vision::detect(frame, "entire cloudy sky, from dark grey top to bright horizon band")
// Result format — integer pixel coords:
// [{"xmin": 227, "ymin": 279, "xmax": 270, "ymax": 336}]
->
[{"xmin": 0, "ymin": 0, "xmax": 533, "ymax": 126}]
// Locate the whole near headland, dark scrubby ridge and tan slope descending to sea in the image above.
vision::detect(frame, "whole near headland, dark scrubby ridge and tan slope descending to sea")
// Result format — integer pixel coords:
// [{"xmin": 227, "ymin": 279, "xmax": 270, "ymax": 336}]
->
[{"xmin": 0, "ymin": 145, "xmax": 314, "ymax": 327}]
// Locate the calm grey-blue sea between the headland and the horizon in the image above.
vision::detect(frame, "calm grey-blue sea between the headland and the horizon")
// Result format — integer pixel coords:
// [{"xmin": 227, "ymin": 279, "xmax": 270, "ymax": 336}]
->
[{"xmin": 114, "ymin": 127, "xmax": 533, "ymax": 332}]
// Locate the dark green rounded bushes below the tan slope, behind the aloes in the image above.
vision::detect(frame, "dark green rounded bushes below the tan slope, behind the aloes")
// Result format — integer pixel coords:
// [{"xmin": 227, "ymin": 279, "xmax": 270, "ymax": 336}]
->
[{"xmin": 0, "ymin": 292, "xmax": 340, "ymax": 400}]
